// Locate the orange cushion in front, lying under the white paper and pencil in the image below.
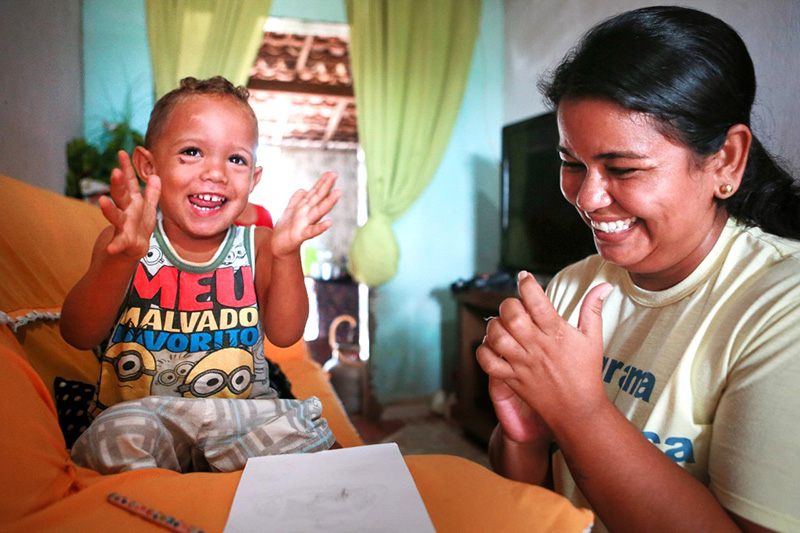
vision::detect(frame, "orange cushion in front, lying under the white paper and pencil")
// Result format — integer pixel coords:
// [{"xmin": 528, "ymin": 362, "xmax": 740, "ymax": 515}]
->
[{"xmin": 9, "ymin": 455, "xmax": 593, "ymax": 533}]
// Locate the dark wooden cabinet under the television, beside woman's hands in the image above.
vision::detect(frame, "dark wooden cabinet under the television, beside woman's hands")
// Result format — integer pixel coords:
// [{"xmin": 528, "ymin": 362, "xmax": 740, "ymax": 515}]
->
[{"xmin": 453, "ymin": 289, "xmax": 516, "ymax": 445}]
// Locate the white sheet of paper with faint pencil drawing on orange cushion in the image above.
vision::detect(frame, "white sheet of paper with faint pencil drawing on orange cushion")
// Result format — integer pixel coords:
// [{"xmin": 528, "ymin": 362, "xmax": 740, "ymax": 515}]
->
[{"xmin": 225, "ymin": 443, "xmax": 435, "ymax": 533}]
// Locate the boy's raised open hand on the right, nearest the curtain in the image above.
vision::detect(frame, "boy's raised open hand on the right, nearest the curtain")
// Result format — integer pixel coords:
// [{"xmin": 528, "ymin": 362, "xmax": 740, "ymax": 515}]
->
[{"xmin": 272, "ymin": 172, "xmax": 342, "ymax": 257}]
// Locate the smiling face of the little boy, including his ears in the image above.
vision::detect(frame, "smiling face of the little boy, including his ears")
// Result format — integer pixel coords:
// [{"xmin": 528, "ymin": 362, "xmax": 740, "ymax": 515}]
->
[{"xmin": 140, "ymin": 96, "xmax": 261, "ymax": 249}]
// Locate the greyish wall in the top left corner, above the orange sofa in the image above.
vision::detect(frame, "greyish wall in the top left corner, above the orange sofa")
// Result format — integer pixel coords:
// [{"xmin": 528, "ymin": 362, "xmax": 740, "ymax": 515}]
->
[{"xmin": 0, "ymin": 0, "xmax": 83, "ymax": 193}]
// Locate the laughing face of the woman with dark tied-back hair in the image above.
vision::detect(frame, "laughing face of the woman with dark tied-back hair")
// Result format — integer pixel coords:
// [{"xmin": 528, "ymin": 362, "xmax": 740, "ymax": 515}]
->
[{"xmin": 558, "ymin": 98, "xmax": 727, "ymax": 290}]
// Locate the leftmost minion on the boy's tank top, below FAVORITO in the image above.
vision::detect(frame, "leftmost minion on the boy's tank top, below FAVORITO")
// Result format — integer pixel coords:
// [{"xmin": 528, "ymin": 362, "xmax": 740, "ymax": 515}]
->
[{"xmin": 97, "ymin": 342, "xmax": 156, "ymax": 409}]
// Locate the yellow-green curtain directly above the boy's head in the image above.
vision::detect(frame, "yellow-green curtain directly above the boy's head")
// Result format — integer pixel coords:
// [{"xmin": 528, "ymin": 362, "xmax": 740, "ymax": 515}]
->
[{"xmin": 146, "ymin": 0, "xmax": 272, "ymax": 98}]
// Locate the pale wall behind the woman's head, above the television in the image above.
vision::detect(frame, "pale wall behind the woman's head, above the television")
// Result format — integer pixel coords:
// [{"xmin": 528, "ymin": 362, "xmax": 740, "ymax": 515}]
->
[{"xmin": 503, "ymin": 0, "xmax": 800, "ymax": 170}]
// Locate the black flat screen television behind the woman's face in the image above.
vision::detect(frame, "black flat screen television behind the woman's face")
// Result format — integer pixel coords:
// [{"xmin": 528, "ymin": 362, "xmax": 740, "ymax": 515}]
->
[{"xmin": 500, "ymin": 113, "xmax": 596, "ymax": 277}]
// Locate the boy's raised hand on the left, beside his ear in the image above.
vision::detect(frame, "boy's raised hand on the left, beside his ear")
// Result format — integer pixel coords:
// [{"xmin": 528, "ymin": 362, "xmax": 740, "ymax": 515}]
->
[{"xmin": 100, "ymin": 151, "xmax": 161, "ymax": 260}]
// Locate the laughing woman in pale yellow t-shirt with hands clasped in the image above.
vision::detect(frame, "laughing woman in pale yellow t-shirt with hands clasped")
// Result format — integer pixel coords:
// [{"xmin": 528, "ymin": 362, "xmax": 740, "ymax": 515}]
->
[{"xmin": 477, "ymin": 7, "xmax": 800, "ymax": 531}]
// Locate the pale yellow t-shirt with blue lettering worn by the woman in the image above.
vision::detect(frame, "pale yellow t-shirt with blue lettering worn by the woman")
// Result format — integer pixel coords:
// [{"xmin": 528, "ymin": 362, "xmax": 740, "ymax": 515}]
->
[{"xmin": 547, "ymin": 219, "xmax": 800, "ymax": 531}]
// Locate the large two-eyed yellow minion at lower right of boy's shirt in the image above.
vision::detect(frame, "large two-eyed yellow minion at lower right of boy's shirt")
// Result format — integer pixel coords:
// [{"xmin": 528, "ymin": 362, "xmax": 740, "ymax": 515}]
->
[{"xmin": 178, "ymin": 347, "xmax": 255, "ymax": 398}]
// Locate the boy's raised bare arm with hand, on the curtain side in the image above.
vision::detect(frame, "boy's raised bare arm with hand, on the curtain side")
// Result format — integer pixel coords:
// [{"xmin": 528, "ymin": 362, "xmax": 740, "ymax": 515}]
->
[{"xmin": 256, "ymin": 172, "xmax": 341, "ymax": 346}]
